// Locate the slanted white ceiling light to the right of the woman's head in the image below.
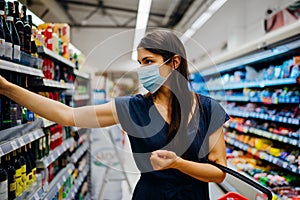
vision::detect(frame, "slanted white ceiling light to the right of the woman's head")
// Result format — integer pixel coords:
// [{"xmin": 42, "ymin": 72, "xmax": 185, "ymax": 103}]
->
[{"xmin": 180, "ymin": 0, "xmax": 227, "ymax": 43}]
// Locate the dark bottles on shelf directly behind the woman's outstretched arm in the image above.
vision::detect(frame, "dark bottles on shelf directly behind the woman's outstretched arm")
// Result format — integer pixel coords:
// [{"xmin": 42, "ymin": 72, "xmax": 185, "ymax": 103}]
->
[{"xmin": 0, "ymin": 70, "xmax": 34, "ymax": 130}]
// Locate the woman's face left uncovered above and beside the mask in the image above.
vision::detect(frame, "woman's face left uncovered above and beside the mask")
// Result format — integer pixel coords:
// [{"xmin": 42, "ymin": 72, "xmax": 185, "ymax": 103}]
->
[{"xmin": 138, "ymin": 48, "xmax": 172, "ymax": 77}]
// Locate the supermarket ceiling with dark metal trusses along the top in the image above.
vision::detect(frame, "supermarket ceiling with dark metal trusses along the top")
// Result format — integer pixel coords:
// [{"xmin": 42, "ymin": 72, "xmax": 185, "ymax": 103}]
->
[{"xmin": 20, "ymin": 0, "xmax": 199, "ymax": 28}]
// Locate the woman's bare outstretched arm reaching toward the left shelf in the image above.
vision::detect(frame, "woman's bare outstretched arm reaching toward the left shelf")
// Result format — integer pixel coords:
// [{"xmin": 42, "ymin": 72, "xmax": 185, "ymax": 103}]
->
[{"xmin": 0, "ymin": 76, "xmax": 118, "ymax": 128}]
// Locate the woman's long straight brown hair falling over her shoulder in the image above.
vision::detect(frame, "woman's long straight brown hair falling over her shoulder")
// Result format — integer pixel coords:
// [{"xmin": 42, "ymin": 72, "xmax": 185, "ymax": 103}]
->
[{"xmin": 138, "ymin": 30, "xmax": 198, "ymax": 153}]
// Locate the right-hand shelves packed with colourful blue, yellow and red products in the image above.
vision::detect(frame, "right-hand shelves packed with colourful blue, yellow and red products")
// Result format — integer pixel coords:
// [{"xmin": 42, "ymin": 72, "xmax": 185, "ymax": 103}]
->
[{"xmin": 192, "ymin": 37, "xmax": 300, "ymax": 200}]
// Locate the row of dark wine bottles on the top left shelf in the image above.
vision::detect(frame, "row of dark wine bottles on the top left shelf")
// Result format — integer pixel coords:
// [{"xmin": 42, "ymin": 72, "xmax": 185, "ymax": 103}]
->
[{"xmin": 0, "ymin": 0, "xmax": 32, "ymax": 63}]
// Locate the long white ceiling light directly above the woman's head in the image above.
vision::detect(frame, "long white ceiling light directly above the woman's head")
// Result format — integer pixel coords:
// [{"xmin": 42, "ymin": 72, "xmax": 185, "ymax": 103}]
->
[{"xmin": 131, "ymin": 0, "xmax": 152, "ymax": 60}]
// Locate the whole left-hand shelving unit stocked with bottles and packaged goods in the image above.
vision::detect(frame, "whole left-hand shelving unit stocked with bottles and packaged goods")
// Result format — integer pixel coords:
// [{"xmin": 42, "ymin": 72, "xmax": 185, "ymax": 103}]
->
[{"xmin": 0, "ymin": 0, "xmax": 90, "ymax": 200}]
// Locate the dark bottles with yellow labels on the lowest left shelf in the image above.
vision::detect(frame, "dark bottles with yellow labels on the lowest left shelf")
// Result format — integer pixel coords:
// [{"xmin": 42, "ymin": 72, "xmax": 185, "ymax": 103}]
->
[{"xmin": 0, "ymin": 143, "xmax": 36, "ymax": 200}]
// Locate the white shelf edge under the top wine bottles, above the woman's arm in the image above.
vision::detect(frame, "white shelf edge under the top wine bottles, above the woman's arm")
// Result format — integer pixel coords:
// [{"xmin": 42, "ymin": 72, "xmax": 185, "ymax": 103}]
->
[{"xmin": 0, "ymin": 59, "xmax": 44, "ymax": 77}]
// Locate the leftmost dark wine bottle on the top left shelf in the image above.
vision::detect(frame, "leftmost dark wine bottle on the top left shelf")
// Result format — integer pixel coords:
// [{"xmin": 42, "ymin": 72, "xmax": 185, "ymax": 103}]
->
[{"xmin": 0, "ymin": 0, "xmax": 13, "ymax": 60}]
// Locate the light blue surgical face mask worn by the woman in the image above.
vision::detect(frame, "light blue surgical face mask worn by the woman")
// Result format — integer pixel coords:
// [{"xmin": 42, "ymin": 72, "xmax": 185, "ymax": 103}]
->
[{"xmin": 138, "ymin": 58, "xmax": 171, "ymax": 94}]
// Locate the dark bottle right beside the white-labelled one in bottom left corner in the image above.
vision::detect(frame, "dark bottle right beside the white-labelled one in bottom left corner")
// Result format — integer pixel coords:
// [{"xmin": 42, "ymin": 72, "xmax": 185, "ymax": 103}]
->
[{"xmin": 4, "ymin": 154, "xmax": 16, "ymax": 200}]
